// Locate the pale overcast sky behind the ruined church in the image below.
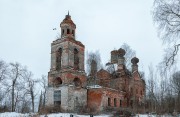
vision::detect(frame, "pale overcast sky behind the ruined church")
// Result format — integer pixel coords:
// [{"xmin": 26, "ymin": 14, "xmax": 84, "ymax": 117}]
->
[{"xmin": 0, "ymin": 0, "xmax": 166, "ymax": 77}]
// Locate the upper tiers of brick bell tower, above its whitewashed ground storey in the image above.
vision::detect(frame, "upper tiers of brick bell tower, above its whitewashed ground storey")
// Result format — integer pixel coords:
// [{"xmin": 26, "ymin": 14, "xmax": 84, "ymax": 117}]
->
[{"xmin": 48, "ymin": 13, "xmax": 85, "ymax": 87}]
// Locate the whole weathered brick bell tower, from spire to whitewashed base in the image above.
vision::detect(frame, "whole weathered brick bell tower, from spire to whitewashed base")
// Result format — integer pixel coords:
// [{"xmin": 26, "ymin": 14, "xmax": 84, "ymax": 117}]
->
[{"xmin": 46, "ymin": 12, "xmax": 87, "ymax": 110}]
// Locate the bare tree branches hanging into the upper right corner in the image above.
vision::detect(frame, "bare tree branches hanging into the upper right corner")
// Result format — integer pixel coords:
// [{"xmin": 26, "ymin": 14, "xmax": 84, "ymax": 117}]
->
[{"xmin": 153, "ymin": 0, "xmax": 180, "ymax": 66}]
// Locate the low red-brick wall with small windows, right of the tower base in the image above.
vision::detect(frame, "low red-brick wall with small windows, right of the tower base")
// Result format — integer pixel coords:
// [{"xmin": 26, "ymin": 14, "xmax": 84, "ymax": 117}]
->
[{"xmin": 87, "ymin": 88, "xmax": 127, "ymax": 112}]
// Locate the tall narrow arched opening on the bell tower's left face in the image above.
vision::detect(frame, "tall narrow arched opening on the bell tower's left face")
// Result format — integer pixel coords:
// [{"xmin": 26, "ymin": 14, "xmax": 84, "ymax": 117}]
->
[{"xmin": 56, "ymin": 48, "xmax": 62, "ymax": 70}]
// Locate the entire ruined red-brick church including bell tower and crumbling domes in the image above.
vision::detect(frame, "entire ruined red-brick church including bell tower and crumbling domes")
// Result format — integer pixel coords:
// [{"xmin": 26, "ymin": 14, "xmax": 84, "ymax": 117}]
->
[{"xmin": 46, "ymin": 13, "xmax": 145, "ymax": 112}]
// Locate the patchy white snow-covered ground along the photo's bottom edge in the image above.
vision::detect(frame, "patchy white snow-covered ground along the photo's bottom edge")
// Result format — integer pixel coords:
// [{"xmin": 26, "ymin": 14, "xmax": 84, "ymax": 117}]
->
[{"xmin": 0, "ymin": 112, "xmax": 180, "ymax": 117}]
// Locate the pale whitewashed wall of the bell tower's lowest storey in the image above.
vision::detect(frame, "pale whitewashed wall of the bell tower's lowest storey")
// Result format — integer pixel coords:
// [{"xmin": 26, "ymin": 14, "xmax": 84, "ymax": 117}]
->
[{"xmin": 46, "ymin": 85, "xmax": 87, "ymax": 112}]
